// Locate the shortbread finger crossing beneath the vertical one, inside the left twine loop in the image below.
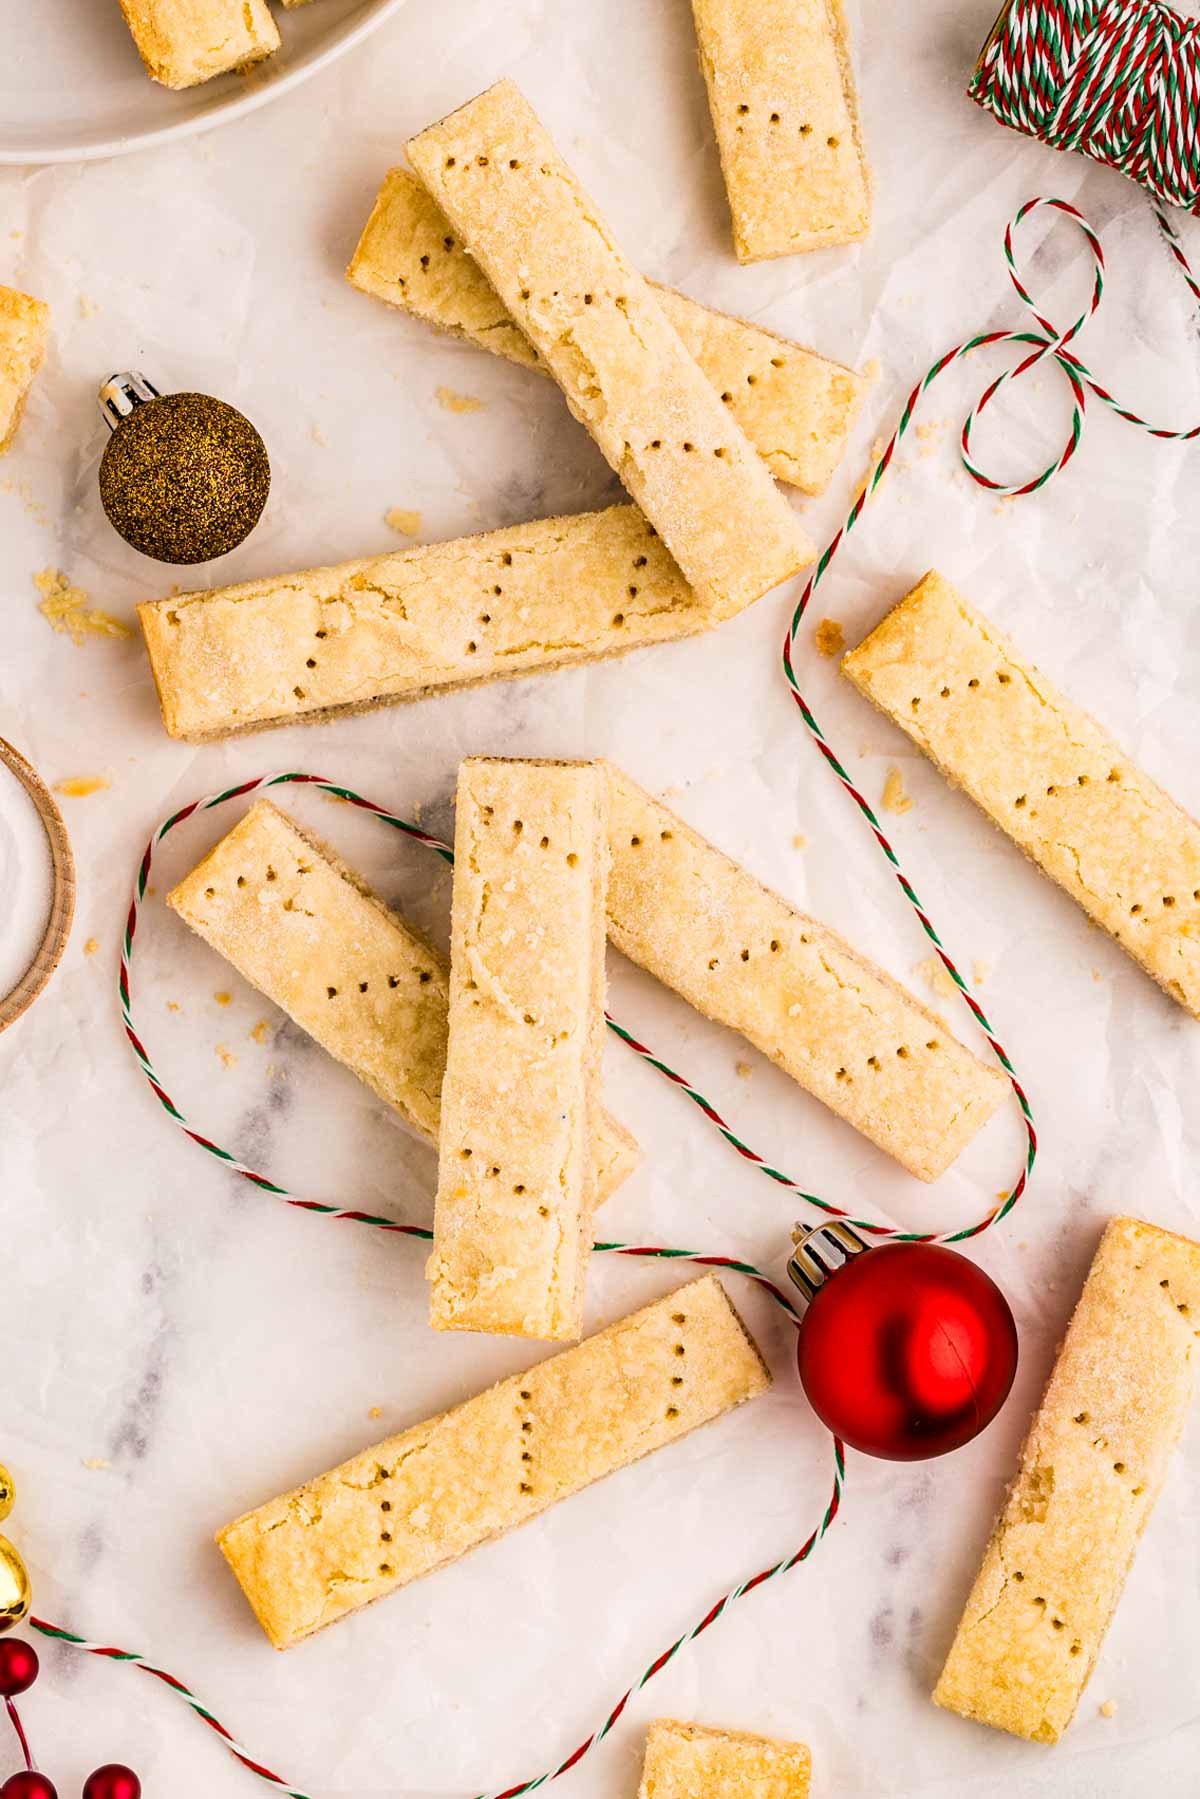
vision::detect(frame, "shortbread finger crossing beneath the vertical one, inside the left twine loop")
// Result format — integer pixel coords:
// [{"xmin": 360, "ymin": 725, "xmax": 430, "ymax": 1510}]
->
[{"xmin": 167, "ymin": 799, "xmax": 639, "ymax": 1196}]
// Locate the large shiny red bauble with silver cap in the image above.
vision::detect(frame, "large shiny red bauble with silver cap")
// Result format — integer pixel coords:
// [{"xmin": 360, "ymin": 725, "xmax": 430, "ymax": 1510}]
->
[{"xmin": 793, "ymin": 1227, "xmax": 1016, "ymax": 1461}]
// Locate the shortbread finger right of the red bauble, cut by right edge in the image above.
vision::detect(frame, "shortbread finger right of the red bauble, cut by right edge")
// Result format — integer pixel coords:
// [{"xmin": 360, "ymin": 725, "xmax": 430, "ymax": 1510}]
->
[{"xmin": 934, "ymin": 1218, "xmax": 1200, "ymax": 1743}]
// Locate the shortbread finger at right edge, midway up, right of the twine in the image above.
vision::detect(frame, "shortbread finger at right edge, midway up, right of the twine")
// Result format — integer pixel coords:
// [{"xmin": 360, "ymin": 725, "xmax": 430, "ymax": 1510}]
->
[{"xmin": 842, "ymin": 574, "xmax": 1200, "ymax": 1016}]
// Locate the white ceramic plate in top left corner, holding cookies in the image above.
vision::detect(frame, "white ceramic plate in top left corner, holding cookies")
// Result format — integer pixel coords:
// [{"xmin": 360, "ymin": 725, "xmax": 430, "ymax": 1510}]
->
[{"xmin": 0, "ymin": 0, "xmax": 405, "ymax": 162}]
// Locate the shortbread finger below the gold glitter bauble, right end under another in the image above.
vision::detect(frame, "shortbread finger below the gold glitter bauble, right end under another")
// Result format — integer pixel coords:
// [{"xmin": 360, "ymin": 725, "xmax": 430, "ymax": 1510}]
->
[{"xmin": 139, "ymin": 506, "xmax": 714, "ymax": 743}]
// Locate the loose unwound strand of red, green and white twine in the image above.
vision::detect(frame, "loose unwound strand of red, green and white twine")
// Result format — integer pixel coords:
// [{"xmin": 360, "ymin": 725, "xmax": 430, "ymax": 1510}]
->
[{"xmin": 51, "ymin": 186, "xmax": 1200, "ymax": 1799}]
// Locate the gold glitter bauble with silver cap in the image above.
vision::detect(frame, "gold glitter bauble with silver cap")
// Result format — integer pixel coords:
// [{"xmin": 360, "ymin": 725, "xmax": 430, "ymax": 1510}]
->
[{"xmin": 99, "ymin": 374, "xmax": 272, "ymax": 563}]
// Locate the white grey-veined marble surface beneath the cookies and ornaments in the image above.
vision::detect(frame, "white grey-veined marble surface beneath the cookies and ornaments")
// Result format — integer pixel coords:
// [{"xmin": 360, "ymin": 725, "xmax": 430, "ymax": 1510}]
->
[{"xmin": 0, "ymin": 0, "xmax": 1200, "ymax": 1799}]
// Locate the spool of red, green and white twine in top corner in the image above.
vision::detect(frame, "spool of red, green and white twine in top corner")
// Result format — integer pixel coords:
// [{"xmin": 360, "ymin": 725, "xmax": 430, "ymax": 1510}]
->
[{"xmin": 968, "ymin": 0, "xmax": 1200, "ymax": 212}]
